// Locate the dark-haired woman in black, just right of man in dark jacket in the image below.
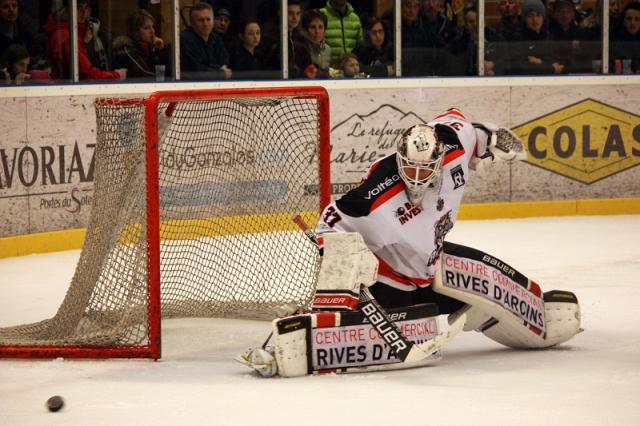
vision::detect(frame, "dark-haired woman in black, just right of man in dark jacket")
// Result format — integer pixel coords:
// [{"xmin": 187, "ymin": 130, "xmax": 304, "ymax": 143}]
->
[{"xmin": 231, "ymin": 19, "xmax": 265, "ymax": 79}]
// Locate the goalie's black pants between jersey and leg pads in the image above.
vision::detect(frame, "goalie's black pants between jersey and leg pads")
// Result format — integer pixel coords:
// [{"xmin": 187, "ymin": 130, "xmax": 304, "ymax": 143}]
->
[{"xmin": 369, "ymin": 282, "xmax": 465, "ymax": 314}]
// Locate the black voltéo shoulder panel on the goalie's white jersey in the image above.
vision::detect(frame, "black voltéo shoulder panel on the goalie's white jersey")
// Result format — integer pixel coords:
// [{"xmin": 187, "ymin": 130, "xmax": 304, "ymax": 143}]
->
[{"xmin": 336, "ymin": 154, "xmax": 403, "ymax": 217}]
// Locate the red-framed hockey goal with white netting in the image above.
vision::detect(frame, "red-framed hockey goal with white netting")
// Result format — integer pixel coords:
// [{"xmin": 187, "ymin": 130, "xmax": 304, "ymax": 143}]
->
[{"xmin": 0, "ymin": 87, "xmax": 331, "ymax": 359}]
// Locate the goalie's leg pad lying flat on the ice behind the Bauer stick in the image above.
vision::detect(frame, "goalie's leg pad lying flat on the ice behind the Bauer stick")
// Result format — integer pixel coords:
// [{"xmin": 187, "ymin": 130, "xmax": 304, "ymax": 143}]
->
[{"xmin": 273, "ymin": 304, "xmax": 446, "ymax": 377}]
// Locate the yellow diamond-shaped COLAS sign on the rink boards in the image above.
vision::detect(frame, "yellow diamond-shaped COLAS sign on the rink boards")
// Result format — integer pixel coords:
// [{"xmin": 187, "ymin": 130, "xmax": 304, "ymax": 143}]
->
[{"xmin": 513, "ymin": 99, "xmax": 640, "ymax": 185}]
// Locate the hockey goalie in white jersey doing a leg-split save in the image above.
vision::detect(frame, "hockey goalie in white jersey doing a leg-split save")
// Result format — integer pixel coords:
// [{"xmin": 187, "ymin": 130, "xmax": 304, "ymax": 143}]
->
[{"xmin": 237, "ymin": 109, "xmax": 581, "ymax": 376}]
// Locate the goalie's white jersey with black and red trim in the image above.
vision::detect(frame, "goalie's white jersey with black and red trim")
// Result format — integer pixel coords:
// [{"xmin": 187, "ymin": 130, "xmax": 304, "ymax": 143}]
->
[{"xmin": 317, "ymin": 109, "xmax": 476, "ymax": 291}]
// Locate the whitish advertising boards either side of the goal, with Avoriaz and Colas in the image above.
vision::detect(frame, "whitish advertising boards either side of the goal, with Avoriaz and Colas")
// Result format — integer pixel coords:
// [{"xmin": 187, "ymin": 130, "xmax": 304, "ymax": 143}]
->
[{"xmin": 0, "ymin": 85, "xmax": 640, "ymax": 237}]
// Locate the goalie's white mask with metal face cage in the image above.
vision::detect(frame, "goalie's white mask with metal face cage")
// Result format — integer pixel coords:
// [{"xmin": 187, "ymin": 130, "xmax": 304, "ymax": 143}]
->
[{"xmin": 396, "ymin": 124, "xmax": 444, "ymax": 205}]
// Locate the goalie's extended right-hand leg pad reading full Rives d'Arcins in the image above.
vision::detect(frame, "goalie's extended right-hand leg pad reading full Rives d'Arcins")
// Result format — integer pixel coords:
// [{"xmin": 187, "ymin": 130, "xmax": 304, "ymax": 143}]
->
[{"xmin": 433, "ymin": 242, "xmax": 581, "ymax": 348}]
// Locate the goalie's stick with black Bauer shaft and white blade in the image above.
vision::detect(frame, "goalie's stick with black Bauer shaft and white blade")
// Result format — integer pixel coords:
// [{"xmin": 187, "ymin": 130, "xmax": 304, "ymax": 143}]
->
[{"xmin": 293, "ymin": 214, "xmax": 470, "ymax": 363}]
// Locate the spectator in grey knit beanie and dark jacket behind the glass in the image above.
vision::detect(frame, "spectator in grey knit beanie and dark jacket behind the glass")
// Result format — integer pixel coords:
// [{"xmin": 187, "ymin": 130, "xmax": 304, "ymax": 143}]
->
[{"xmin": 512, "ymin": 0, "xmax": 564, "ymax": 75}]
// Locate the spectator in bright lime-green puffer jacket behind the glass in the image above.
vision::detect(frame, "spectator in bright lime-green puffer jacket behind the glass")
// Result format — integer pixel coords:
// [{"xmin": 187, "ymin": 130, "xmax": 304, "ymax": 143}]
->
[{"xmin": 320, "ymin": 0, "xmax": 362, "ymax": 60}]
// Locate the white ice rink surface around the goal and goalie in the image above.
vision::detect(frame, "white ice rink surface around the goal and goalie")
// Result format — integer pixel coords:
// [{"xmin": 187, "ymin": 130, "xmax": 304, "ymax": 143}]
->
[{"xmin": 0, "ymin": 215, "xmax": 640, "ymax": 426}]
